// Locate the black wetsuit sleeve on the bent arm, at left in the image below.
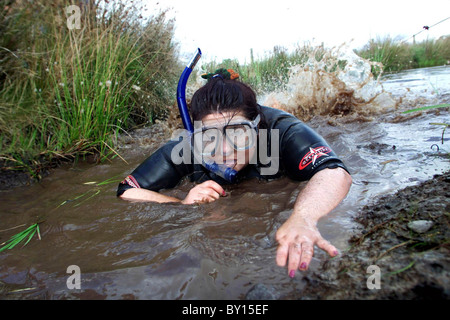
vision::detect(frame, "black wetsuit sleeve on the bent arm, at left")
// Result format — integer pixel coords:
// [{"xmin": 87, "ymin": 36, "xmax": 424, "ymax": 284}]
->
[{"xmin": 117, "ymin": 141, "xmax": 190, "ymax": 196}]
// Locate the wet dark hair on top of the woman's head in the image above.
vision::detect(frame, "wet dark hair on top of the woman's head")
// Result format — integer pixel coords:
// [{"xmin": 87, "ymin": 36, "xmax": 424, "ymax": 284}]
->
[{"xmin": 191, "ymin": 75, "xmax": 264, "ymax": 127}]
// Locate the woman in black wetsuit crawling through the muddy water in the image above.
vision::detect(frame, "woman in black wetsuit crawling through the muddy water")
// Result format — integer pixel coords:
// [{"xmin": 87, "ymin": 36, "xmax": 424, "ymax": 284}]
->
[{"xmin": 117, "ymin": 69, "xmax": 352, "ymax": 277}]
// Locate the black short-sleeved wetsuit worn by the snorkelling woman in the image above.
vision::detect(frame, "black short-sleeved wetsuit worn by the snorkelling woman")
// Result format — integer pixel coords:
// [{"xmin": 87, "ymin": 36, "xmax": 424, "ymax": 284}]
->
[{"xmin": 117, "ymin": 107, "xmax": 348, "ymax": 196}]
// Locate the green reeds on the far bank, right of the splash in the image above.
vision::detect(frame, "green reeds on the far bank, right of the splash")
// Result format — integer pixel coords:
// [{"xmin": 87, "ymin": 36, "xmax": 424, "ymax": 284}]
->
[{"xmin": 356, "ymin": 36, "xmax": 450, "ymax": 72}]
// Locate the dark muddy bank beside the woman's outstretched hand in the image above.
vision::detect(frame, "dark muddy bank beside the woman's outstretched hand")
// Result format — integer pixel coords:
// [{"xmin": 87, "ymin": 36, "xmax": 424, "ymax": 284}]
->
[{"xmin": 284, "ymin": 172, "xmax": 450, "ymax": 300}]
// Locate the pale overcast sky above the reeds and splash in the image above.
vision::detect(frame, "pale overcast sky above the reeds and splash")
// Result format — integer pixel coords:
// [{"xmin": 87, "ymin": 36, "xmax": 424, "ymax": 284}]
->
[{"xmin": 143, "ymin": 0, "xmax": 450, "ymax": 62}]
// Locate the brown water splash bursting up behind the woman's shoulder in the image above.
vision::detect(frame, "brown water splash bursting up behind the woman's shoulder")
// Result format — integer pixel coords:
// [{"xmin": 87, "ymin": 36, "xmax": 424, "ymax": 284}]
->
[{"xmin": 260, "ymin": 45, "xmax": 398, "ymax": 121}]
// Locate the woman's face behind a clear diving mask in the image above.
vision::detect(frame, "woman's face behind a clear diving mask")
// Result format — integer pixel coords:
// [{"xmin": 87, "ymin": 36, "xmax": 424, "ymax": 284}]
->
[{"xmin": 197, "ymin": 112, "xmax": 257, "ymax": 171}]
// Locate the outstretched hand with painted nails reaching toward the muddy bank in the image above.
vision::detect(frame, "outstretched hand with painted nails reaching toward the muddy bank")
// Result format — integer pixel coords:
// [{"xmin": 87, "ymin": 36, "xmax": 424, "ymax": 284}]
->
[{"xmin": 276, "ymin": 217, "xmax": 338, "ymax": 278}]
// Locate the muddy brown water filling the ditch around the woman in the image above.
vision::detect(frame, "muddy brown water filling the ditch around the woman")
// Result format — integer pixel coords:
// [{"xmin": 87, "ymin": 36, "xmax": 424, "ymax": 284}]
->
[{"xmin": 0, "ymin": 63, "xmax": 450, "ymax": 299}]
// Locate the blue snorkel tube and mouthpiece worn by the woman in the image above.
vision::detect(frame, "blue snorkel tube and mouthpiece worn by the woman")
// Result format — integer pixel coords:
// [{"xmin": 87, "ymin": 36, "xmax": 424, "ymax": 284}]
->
[{"xmin": 177, "ymin": 49, "xmax": 237, "ymax": 183}]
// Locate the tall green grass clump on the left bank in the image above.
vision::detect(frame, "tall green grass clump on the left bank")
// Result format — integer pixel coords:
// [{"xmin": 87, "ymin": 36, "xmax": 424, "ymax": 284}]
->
[{"xmin": 0, "ymin": 0, "xmax": 182, "ymax": 177}]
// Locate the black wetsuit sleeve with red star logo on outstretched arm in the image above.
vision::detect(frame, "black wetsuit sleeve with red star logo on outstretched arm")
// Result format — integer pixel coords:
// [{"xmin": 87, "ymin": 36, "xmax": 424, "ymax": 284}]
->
[{"xmin": 280, "ymin": 121, "xmax": 348, "ymax": 181}]
